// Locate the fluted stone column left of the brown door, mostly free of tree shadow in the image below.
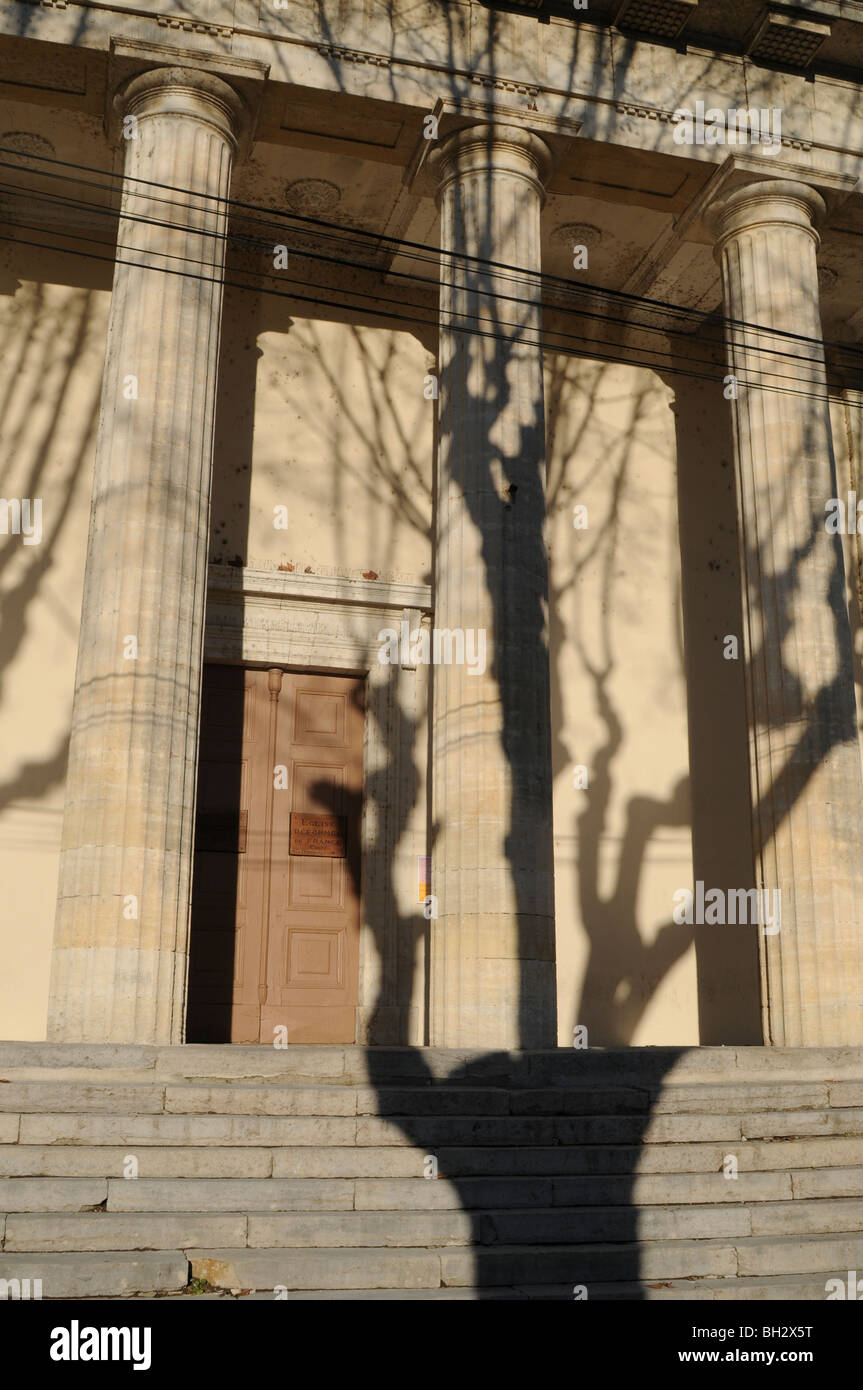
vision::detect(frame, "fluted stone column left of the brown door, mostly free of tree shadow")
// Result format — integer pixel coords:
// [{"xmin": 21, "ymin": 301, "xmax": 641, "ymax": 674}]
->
[{"xmin": 49, "ymin": 68, "xmax": 243, "ymax": 1043}]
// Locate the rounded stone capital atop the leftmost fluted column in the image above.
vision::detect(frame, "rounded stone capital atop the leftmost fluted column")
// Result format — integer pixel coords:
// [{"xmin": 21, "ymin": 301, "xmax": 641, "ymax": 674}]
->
[{"xmin": 110, "ymin": 67, "xmax": 249, "ymax": 150}]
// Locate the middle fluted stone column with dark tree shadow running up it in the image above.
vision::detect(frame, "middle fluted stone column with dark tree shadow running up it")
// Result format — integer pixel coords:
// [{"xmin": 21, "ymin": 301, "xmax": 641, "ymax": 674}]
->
[{"xmin": 431, "ymin": 125, "xmax": 556, "ymax": 1048}]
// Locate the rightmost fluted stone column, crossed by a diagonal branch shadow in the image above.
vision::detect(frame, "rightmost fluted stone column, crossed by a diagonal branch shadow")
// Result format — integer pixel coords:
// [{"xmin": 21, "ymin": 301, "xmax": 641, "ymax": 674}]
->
[{"xmin": 712, "ymin": 179, "xmax": 863, "ymax": 1047}]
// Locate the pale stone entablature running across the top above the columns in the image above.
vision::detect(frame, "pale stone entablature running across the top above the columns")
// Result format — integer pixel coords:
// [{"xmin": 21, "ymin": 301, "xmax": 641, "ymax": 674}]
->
[{"xmin": 0, "ymin": 0, "xmax": 863, "ymax": 186}]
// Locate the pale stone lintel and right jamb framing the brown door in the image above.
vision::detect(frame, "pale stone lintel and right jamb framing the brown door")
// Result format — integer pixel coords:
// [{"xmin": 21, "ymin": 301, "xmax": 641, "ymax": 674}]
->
[{"xmin": 203, "ymin": 564, "xmax": 432, "ymax": 1047}]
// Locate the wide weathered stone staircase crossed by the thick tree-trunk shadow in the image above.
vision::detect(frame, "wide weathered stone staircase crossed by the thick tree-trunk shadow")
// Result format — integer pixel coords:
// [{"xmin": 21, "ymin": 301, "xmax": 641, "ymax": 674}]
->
[{"xmin": 0, "ymin": 1043, "xmax": 863, "ymax": 1300}]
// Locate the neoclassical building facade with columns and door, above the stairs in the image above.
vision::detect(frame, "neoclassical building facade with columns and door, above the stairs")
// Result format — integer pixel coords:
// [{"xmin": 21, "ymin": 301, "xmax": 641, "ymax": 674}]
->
[{"xmin": 0, "ymin": 0, "xmax": 863, "ymax": 1051}]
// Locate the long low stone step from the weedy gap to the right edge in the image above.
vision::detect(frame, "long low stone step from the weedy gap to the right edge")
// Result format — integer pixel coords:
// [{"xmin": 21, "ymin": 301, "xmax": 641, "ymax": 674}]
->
[{"xmin": 188, "ymin": 1236, "xmax": 863, "ymax": 1290}]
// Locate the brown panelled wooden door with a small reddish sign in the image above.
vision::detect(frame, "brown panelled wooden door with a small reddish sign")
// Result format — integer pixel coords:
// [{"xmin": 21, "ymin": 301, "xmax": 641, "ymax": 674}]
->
[{"xmin": 188, "ymin": 666, "xmax": 364, "ymax": 1044}]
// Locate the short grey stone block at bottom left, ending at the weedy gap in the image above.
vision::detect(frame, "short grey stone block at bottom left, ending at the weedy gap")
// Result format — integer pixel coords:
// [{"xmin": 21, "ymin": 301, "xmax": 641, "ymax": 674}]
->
[{"xmin": 0, "ymin": 1250, "xmax": 189, "ymax": 1300}]
